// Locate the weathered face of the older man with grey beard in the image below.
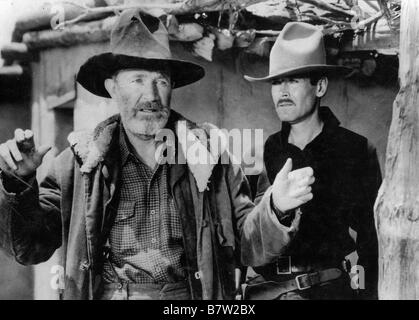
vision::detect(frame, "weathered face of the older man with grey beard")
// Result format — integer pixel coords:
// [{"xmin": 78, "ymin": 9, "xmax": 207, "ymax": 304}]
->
[{"xmin": 105, "ymin": 69, "xmax": 172, "ymax": 136}]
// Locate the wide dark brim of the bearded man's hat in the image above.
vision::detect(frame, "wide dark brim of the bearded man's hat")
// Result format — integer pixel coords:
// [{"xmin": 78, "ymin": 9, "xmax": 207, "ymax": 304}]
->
[{"xmin": 76, "ymin": 52, "xmax": 205, "ymax": 98}]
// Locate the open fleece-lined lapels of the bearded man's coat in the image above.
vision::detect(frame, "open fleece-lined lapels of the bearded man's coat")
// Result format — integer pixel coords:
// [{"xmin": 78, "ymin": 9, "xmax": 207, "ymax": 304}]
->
[{"xmin": 68, "ymin": 111, "xmax": 230, "ymax": 299}]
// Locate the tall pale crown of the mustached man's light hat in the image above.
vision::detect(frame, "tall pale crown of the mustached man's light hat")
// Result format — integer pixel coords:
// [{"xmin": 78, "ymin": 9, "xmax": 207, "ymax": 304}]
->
[{"xmin": 269, "ymin": 22, "xmax": 326, "ymax": 75}]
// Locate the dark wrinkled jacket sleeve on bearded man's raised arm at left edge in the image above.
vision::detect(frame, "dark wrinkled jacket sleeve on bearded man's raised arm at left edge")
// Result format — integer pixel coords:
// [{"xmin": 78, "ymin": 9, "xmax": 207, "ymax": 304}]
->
[{"xmin": 0, "ymin": 154, "xmax": 68, "ymax": 265}]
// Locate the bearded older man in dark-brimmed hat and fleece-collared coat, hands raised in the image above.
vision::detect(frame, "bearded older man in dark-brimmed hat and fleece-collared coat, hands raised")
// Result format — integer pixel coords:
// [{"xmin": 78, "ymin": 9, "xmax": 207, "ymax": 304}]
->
[{"xmin": 0, "ymin": 10, "xmax": 314, "ymax": 299}]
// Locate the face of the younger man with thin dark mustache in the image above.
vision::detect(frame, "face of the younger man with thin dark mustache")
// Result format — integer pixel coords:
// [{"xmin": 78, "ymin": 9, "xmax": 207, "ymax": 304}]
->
[{"xmin": 272, "ymin": 77, "xmax": 327, "ymax": 124}]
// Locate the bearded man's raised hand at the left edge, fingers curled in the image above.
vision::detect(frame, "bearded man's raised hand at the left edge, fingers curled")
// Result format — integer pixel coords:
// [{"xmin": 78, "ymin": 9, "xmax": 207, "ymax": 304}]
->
[{"xmin": 0, "ymin": 129, "xmax": 51, "ymax": 178}]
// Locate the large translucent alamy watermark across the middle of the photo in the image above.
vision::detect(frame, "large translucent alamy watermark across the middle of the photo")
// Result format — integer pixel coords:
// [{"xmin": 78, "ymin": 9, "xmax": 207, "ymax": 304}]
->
[{"xmin": 155, "ymin": 121, "xmax": 264, "ymax": 175}]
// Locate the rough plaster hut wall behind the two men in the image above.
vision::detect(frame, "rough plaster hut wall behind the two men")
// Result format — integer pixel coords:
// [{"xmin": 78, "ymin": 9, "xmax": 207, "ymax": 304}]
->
[{"xmin": 27, "ymin": 43, "xmax": 397, "ymax": 299}]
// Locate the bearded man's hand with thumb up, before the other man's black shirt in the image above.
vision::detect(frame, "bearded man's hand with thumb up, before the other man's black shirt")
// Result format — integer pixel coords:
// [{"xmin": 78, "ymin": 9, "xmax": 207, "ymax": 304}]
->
[{"xmin": 272, "ymin": 159, "xmax": 314, "ymax": 212}]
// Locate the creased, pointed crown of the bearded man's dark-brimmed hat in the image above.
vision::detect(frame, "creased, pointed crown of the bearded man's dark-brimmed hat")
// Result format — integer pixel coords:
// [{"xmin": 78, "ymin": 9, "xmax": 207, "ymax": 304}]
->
[{"xmin": 110, "ymin": 9, "xmax": 172, "ymax": 59}]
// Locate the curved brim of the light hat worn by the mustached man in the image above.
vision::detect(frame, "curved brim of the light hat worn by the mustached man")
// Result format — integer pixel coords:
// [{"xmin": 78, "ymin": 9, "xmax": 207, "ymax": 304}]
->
[{"xmin": 244, "ymin": 64, "xmax": 352, "ymax": 82}]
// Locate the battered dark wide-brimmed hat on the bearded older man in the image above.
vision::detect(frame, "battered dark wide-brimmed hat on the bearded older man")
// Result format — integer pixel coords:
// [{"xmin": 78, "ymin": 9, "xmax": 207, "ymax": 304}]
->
[{"xmin": 77, "ymin": 9, "xmax": 205, "ymax": 98}]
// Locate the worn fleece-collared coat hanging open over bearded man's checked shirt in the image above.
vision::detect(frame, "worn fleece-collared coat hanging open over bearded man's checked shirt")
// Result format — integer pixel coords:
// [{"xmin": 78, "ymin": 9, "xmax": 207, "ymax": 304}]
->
[{"xmin": 0, "ymin": 111, "xmax": 290, "ymax": 299}]
